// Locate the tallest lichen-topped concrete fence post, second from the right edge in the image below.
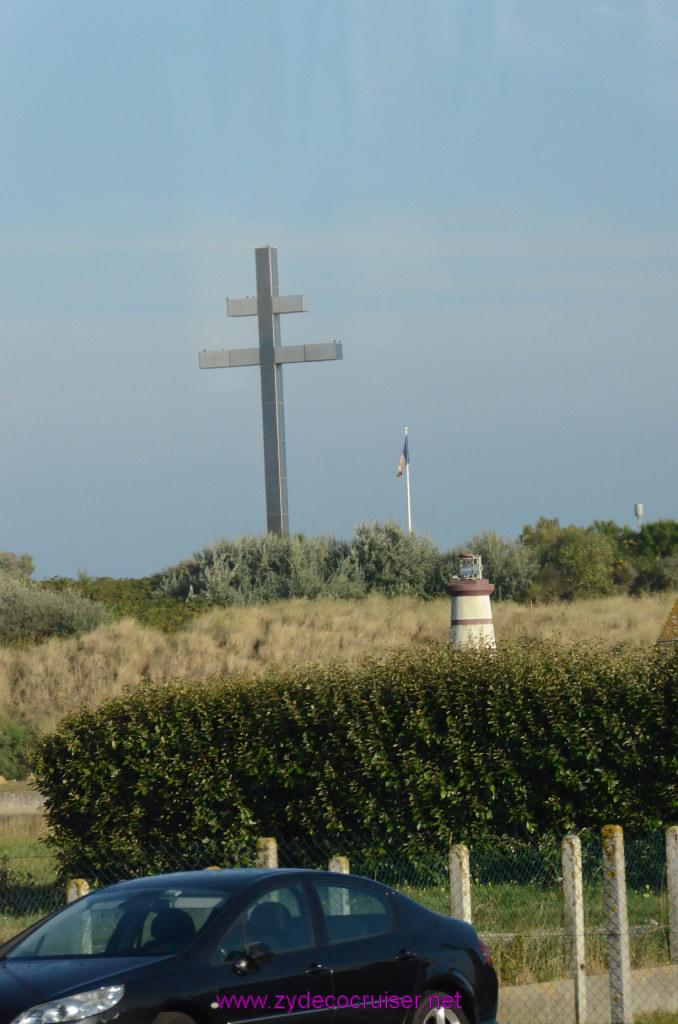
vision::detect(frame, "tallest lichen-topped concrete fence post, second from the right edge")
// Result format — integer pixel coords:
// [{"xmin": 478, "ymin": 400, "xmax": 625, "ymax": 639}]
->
[{"xmin": 602, "ymin": 825, "xmax": 633, "ymax": 1024}]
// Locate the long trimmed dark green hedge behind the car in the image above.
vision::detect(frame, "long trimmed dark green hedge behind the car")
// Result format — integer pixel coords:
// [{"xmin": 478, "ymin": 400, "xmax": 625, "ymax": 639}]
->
[{"xmin": 36, "ymin": 643, "xmax": 678, "ymax": 869}]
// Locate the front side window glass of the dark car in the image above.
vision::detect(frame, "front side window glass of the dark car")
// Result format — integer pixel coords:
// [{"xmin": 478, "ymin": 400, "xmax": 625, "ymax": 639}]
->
[{"xmin": 243, "ymin": 885, "xmax": 313, "ymax": 953}]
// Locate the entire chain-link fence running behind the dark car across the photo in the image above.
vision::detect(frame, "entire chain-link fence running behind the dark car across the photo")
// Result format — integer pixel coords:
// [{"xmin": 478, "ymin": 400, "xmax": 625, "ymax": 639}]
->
[{"xmin": 0, "ymin": 829, "xmax": 678, "ymax": 1024}]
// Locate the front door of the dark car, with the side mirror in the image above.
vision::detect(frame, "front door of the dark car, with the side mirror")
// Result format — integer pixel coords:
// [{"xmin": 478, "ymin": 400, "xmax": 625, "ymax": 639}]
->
[{"xmin": 200, "ymin": 883, "xmax": 333, "ymax": 1024}]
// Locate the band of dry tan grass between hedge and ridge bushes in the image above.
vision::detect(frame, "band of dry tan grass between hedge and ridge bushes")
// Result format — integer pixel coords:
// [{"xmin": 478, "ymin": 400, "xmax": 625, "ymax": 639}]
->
[{"xmin": 0, "ymin": 595, "xmax": 676, "ymax": 729}]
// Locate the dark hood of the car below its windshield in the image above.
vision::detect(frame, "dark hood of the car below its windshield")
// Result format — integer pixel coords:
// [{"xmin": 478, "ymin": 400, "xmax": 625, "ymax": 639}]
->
[{"xmin": 0, "ymin": 956, "xmax": 156, "ymax": 1024}]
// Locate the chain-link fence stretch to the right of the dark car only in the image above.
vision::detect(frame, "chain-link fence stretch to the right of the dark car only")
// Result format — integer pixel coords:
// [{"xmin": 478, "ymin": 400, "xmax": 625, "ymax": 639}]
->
[{"xmin": 469, "ymin": 834, "xmax": 678, "ymax": 1024}]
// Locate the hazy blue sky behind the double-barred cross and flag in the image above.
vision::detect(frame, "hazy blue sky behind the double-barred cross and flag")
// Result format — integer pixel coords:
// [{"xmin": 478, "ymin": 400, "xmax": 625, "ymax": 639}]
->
[{"xmin": 0, "ymin": 0, "xmax": 678, "ymax": 579}]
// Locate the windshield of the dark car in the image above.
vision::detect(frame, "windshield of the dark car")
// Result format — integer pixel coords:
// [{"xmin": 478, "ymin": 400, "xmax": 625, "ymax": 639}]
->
[{"xmin": 6, "ymin": 887, "xmax": 234, "ymax": 959}]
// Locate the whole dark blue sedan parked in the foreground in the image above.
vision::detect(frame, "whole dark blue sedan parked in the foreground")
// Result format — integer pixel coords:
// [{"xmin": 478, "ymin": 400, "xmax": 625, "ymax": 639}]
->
[{"xmin": 0, "ymin": 869, "xmax": 497, "ymax": 1024}]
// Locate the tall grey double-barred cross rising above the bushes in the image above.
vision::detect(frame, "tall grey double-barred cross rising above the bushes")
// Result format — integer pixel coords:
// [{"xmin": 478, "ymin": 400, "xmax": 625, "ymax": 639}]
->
[{"xmin": 200, "ymin": 246, "xmax": 342, "ymax": 536}]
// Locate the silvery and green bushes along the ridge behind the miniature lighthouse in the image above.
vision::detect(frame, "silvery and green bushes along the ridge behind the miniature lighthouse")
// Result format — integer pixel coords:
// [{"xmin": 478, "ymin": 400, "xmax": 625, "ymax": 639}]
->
[{"xmin": 158, "ymin": 517, "xmax": 678, "ymax": 604}]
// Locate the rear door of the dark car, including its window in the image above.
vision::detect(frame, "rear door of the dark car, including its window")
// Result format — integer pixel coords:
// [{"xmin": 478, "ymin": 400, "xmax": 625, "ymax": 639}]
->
[{"xmin": 310, "ymin": 879, "xmax": 423, "ymax": 1024}]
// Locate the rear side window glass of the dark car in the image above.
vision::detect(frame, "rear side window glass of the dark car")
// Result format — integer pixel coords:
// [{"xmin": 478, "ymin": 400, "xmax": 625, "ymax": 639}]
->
[{"xmin": 313, "ymin": 882, "xmax": 395, "ymax": 942}]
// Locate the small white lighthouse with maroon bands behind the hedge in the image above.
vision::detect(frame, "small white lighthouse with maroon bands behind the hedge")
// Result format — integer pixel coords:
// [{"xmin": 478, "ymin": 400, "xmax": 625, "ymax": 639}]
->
[{"xmin": 446, "ymin": 554, "xmax": 497, "ymax": 650}]
